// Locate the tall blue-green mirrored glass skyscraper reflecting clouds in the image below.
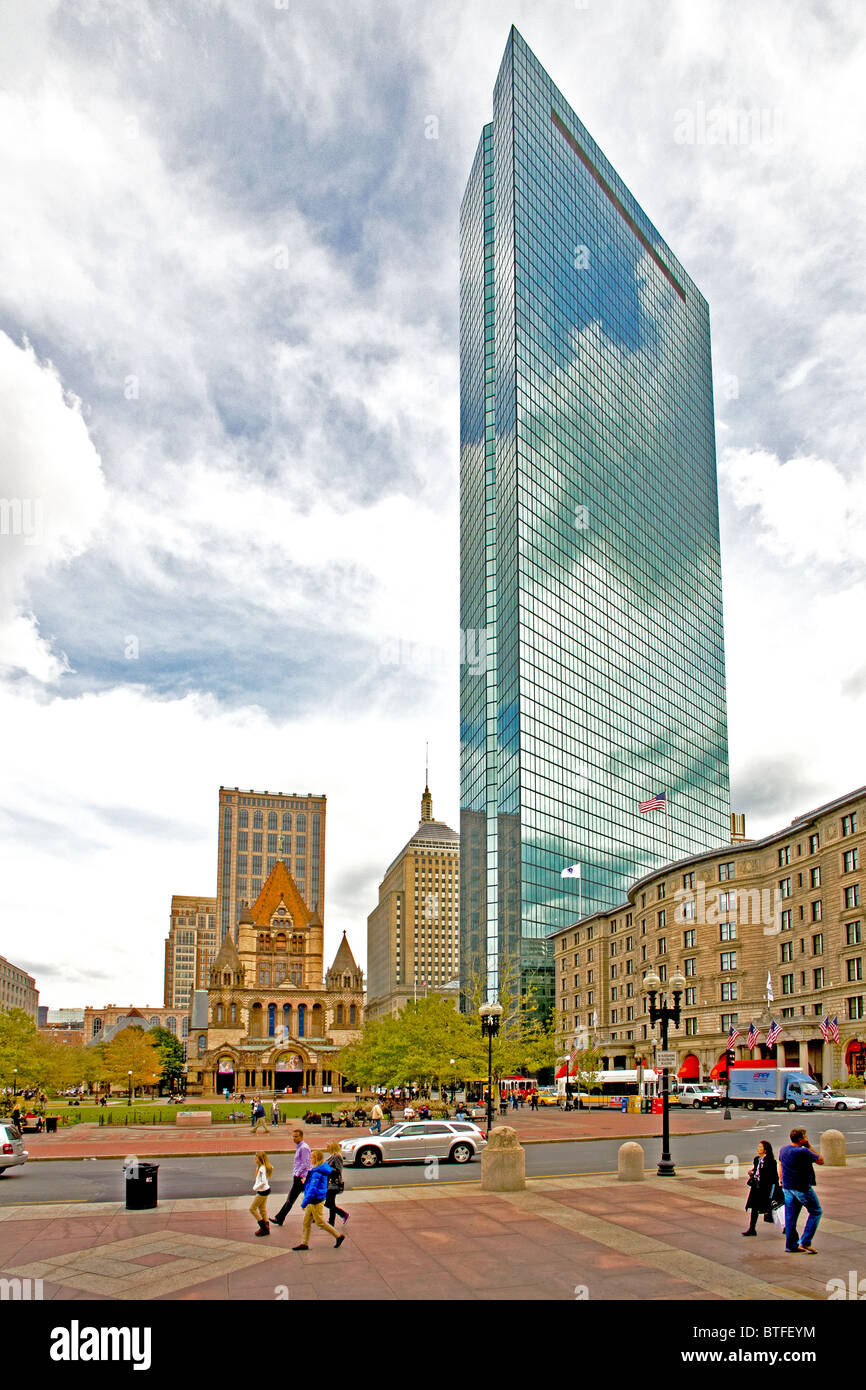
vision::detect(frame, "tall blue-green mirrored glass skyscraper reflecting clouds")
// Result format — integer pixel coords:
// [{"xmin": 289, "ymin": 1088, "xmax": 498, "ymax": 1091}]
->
[{"xmin": 460, "ymin": 29, "xmax": 730, "ymax": 1001}]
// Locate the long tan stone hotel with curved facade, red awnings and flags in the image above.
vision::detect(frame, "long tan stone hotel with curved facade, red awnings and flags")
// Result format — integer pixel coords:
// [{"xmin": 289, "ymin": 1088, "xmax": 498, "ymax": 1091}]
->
[{"xmin": 552, "ymin": 787, "xmax": 866, "ymax": 1083}]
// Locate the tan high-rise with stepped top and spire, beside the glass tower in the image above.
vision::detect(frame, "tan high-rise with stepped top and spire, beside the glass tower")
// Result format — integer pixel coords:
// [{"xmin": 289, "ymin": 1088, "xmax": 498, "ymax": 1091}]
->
[{"xmin": 367, "ymin": 787, "xmax": 460, "ymax": 1019}]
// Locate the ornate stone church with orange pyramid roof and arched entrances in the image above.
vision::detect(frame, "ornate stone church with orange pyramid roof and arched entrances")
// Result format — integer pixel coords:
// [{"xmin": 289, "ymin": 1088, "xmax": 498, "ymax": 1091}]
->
[{"xmin": 188, "ymin": 859, "xmax": 364, "ymax": 1095}]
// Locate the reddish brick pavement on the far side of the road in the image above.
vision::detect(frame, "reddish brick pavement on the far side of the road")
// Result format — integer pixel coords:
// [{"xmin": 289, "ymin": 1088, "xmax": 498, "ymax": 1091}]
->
[{"xmin": 25, "ymin": 1109, "xmax": 755, "ymax": 1158}]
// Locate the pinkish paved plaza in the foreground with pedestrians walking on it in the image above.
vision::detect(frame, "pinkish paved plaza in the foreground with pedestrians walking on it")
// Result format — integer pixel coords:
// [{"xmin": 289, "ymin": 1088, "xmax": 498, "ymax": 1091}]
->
[{"xmin": 0, "ymin": 1158, "xmax": 866, "ymax": 1301}]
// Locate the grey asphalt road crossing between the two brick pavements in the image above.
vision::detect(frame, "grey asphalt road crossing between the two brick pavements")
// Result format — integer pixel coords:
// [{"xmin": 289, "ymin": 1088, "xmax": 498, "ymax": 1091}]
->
[{"xmin": 0, "ymin": 1111, "xmax": 866, "ymax": 1207}]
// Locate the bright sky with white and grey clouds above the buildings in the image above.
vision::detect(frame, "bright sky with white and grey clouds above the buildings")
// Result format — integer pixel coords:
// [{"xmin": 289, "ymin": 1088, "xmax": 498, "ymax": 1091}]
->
[{"xmin": 0, "ymin": 0, "xmax": 866, "ymax": 1008}]
